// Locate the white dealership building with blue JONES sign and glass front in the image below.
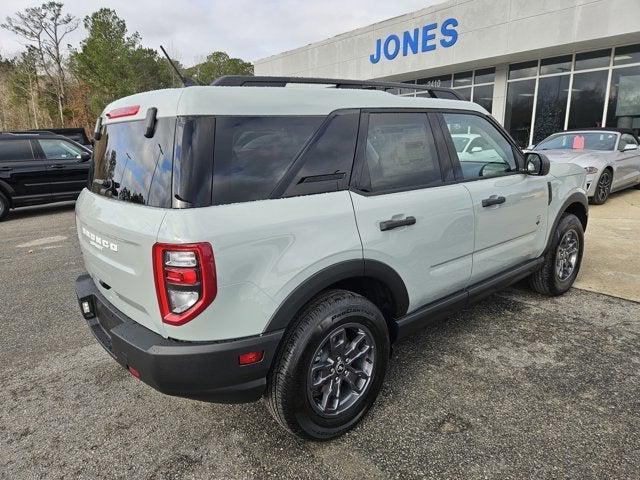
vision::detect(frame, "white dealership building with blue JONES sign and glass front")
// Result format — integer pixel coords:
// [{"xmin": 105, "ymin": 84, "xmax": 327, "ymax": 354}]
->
[{"xmin": 255, "ymin": 0, "xmax": 640, "ymax": 147}]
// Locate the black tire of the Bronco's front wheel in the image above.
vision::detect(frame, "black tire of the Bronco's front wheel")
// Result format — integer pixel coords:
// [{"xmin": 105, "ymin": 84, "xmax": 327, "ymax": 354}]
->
[{"xmin": 529, "ymin": 213, "xmax": 584, "ymax": 296}]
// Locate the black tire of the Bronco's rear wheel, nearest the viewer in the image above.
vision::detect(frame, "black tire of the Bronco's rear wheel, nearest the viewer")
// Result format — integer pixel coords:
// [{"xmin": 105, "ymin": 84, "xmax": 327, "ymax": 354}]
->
[{"xmin": 265, "ymin": 290, "xmax": 390, "ymax": 440}]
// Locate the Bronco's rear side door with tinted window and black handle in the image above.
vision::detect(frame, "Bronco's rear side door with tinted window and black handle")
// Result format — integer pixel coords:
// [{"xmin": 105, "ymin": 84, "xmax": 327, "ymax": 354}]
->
[{"xmin": 351, "ymin": 110, "xmax": 474, "ymax": 311}]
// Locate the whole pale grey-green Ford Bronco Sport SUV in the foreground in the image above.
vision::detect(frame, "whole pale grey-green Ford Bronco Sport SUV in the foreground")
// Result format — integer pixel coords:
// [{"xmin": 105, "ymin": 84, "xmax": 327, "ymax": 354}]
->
[{"xmin": 76, "ymin": 77, "xmax": 588, "ymax": 439}]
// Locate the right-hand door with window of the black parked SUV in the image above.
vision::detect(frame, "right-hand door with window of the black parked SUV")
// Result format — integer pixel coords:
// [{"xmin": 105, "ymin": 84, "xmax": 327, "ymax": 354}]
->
[{"xmin": 35, "ymin": 138, "xmax": 90, "ymax": 200}]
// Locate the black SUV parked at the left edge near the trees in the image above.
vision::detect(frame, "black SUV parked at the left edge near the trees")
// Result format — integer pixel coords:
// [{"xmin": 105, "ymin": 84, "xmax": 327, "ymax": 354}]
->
[{"xmin": 0, "ymin": 133, "xmax": 91, "ymax": 220}]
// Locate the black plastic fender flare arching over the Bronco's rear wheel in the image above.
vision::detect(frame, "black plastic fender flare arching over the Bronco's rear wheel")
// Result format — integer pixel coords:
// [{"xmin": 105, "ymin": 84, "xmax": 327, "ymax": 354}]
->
[{"xmin": 263, "ymin": 259, "xmax": 409, "ymax": 333}]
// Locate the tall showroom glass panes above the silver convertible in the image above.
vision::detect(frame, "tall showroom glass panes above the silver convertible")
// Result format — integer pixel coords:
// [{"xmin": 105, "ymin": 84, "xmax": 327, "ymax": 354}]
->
[{"xmin": 505, "ymin": 45, "xmax": 640, "ymax": 147}]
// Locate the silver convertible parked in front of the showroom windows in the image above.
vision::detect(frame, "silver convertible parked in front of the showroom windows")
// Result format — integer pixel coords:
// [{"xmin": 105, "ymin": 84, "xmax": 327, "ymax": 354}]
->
[{"xmin": 533, "ymin": 128, "xmax": 640, "ymax": 205}]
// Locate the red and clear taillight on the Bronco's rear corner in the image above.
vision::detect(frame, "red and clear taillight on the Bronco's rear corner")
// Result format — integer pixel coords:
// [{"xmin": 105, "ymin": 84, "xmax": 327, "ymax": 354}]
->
[{"xmin": 153, "ymin": 243, "xmax": 218, "ymax": 325}]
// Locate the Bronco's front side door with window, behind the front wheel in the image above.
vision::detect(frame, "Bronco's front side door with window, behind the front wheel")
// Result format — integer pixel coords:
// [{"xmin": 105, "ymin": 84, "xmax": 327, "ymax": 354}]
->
[{"xmin": 441, "ymin": 112, "xmax": 549, "ymax": 284}]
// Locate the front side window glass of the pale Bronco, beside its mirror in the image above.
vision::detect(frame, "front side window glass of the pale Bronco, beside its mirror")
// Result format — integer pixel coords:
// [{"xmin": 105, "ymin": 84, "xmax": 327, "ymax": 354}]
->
[{"xmin": 443, "ymin": 113, "xmax": 518, "ymax": 180}]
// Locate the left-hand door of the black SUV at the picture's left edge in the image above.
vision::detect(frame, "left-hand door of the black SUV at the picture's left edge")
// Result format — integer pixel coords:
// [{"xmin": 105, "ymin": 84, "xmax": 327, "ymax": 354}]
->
[{"xmin": 0, "ymin": 138, "xmax": 51, "ymax": 206}]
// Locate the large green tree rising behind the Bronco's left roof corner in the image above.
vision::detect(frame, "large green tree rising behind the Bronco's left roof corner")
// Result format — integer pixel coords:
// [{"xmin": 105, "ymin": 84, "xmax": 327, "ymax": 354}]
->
[{"xmin": 71, "ymin": 8, "xmax": 172, "ymax": 116}]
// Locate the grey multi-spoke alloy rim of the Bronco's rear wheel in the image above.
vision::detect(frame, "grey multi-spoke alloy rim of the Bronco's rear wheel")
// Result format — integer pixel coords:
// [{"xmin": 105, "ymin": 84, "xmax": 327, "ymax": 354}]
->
[{"xmin": 307, "ymin": 323, "xmax": 375, "ymax": 416}]
